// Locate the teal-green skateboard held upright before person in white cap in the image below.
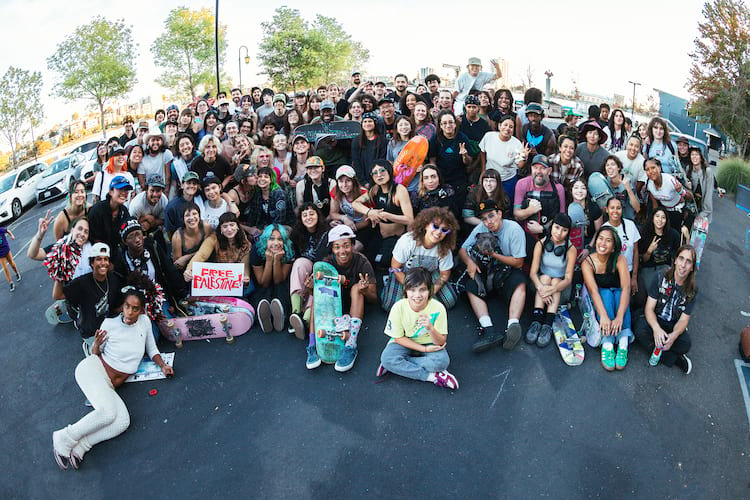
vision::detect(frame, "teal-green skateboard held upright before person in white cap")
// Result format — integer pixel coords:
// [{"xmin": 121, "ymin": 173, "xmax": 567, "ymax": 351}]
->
[{"xmin": 313, "ymin": 262, "xmax": 344, "ymax": 364}]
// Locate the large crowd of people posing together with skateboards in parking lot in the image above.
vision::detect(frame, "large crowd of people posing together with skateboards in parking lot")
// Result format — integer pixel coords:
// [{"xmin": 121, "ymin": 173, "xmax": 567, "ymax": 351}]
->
[{"xmin": 33, "ymin": 58, "xmax": 750, "ymax": 468}]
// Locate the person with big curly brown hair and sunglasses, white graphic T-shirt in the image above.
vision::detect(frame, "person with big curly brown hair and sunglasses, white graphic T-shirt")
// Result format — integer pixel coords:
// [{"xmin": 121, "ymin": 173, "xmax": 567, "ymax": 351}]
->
[{"xmin": 380, "ymin": 207, "xmax": 459, "ymax": 311}]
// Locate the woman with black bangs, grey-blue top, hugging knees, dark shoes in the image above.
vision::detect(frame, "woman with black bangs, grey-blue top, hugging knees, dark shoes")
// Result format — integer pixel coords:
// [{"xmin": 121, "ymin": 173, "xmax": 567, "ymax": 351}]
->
[{"xmin": 526, "ymin": 213, "xmax": 578, "ymax": 347}]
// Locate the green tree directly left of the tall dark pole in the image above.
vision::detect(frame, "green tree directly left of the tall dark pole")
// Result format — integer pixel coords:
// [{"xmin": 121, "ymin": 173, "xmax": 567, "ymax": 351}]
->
[{"xmin": 151, "ymin": 7, "xmax": 227, "ymax": 98}]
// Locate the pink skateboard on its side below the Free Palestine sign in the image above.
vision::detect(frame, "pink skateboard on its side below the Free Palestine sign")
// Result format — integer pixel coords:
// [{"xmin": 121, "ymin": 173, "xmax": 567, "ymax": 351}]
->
[{"xmin": 159, "ymin": 312, "xmax": 253, "ymax": 348}]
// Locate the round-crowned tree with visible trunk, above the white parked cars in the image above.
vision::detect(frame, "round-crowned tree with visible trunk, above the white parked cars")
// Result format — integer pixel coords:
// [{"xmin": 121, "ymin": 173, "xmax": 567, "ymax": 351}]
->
[{"xmin": 47, "ymin": 16, "xmax": 137, "ymax": 140}]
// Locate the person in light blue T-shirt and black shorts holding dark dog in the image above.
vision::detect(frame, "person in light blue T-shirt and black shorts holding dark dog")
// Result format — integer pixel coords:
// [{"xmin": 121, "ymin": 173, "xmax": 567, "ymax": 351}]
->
[{"xmin": 458, "ymin": 200, "xmax": 526, "ymax": 352}]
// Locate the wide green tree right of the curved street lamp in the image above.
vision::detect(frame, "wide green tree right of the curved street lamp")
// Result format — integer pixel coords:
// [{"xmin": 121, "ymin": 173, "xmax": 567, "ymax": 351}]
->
[{"xmin": 258, "ymin": 7, "xmax": 369, "ymax": 90}]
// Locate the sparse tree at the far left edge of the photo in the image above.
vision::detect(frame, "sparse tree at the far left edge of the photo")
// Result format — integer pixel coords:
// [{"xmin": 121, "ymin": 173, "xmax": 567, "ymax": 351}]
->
[{"xmin": 0, "ymin": 66, "xmax": 43, "ymax": 169}]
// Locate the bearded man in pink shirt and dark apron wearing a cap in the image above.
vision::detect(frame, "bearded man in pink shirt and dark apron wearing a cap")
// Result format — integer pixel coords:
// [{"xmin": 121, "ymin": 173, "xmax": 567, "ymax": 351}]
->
[{"xmin": 513, "ymin": 155, "xmax": 565, "ymax": 260}]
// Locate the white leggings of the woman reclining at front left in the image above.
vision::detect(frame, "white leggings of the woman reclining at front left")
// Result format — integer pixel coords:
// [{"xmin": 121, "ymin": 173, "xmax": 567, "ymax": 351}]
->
[{"xmin": 57, "ymin": 356, "xmax": 130, "ymax": 458}]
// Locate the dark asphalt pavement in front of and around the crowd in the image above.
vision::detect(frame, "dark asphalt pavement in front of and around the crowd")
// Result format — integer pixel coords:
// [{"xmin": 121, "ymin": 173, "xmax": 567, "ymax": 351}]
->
[{"xmin": 0, "ymin": 192, "xmax": 750, "ymax": 499}]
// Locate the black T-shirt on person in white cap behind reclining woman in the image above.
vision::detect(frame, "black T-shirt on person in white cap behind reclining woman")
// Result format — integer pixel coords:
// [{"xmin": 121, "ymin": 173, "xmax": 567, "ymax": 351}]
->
[{"xmin": 63, "ymin": 272, "xmax": 122, "ymax": 338}]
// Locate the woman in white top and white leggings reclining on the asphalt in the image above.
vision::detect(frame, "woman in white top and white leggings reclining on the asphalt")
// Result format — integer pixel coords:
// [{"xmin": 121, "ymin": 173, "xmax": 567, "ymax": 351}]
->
[{"xmin": 52, "ymin": 287, "xmax": 174, "ymax": 469}]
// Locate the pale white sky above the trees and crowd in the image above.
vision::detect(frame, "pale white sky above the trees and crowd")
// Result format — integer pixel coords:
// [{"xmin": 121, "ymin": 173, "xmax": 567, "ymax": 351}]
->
[{"xmin": 0, "ymin": 0, "xmax": 703, "ymax": 145}]
